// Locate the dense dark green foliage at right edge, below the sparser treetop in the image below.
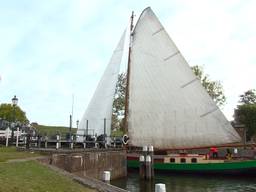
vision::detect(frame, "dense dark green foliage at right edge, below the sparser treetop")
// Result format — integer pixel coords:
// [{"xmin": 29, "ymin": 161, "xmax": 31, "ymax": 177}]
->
[{"xmin": 235, "ymin": 104, "xmax": 256, "ymax": 140}]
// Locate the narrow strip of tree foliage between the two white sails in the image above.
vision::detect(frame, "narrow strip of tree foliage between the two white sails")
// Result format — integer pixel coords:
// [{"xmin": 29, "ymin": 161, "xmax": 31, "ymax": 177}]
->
[{"xmin": 112, "ymin": 73, "xmax": 126, "ymax": 129}]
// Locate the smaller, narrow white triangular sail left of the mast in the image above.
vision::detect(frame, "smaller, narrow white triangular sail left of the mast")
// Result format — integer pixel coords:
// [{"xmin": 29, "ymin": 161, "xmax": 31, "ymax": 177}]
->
[{"xmin": 77, "ymin": 32, "xmax": 125, "ymax": 136}]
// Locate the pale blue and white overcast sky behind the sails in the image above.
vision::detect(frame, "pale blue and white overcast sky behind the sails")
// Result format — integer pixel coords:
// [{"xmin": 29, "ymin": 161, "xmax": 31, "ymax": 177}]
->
[{"xmin": 0, "ymin": 0, "xmax": 256, "ymax": 126}]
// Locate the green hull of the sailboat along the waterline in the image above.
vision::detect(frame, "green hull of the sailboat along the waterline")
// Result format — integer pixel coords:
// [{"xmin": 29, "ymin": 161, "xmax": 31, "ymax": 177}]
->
[{"xmin": 127, "ymin": 160, "xmax": 256, "ymax": 174}]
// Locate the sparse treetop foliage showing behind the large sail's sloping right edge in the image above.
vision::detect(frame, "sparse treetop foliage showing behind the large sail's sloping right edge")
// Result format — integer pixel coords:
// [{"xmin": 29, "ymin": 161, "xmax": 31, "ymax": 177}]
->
[{"xmin": 191, "ymin": 65, "xmax": 226, "ymax": 106}]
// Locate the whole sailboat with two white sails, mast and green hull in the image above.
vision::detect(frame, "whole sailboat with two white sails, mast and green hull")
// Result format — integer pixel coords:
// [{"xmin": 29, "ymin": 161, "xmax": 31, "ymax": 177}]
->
[{"xmin": 78, "ymin": 7, "xmax": 256, "ymax": 172}]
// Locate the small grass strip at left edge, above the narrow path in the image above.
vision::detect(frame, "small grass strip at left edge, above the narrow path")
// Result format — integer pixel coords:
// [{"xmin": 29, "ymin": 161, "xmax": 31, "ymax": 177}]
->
[{"xmin": 0, "ymin": 147, "xmax": 40, "ymax": 162}]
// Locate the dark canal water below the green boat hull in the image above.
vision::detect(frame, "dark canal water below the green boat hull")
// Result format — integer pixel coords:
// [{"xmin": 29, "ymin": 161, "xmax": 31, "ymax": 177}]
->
[{"xmin": 111, "ymin": 172, "xmax": 256, "ymax": 192}]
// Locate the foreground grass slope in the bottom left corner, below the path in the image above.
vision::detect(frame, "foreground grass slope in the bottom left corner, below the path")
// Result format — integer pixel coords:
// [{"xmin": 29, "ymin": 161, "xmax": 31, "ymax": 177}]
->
[{"xmin": 0, "ymin": 161, "xmax": 95, "ymax": 192}]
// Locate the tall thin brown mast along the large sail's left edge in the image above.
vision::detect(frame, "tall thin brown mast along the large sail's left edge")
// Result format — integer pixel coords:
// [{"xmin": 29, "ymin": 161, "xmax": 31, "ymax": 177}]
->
[{"xmin": 124, "ymin": 11, "xmax": 134, "ymax": 134}]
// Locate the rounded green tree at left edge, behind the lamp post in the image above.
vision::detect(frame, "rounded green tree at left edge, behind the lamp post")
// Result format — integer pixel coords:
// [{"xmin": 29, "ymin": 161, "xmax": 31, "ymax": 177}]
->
[{"xmin": 0, "ymin": 103, "xmax": 29, "ymax": 124}]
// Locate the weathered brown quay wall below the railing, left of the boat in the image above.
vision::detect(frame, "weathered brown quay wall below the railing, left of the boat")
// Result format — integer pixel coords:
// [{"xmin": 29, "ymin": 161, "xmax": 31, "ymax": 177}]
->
[{"xmin": 46, "ymin": 150, "xmax": 127, "ymax": 180}]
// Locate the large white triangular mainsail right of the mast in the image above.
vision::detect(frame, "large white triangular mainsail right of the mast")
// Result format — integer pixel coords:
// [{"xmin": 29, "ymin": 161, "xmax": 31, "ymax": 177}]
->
[{"xmin": 128, "ymin": 8, "xmax": 240, "ymax": 148}]
